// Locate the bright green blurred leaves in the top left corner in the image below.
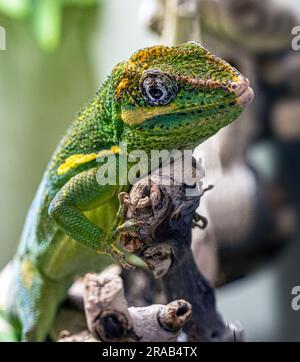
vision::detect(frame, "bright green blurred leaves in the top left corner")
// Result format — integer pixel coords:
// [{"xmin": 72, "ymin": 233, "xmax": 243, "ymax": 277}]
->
[{"xmin": 0, "ymin": 0, "xmax": 99, "ymax": 52}]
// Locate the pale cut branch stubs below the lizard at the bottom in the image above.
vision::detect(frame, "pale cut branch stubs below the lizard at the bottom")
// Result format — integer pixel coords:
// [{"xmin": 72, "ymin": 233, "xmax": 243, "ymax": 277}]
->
[{"xmin": 60, "ymin": 273, "xmax": 191, "ymax": 342}]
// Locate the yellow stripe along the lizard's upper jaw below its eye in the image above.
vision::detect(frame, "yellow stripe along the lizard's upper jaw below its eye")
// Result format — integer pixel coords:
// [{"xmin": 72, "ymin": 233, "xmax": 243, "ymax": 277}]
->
[{"xmin": 121, "ymin": 106, "xmax": 175, "ymax": 125}]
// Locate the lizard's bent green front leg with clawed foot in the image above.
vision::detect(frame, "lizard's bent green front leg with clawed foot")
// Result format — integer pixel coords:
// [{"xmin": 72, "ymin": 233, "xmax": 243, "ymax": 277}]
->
[{"xmin": 49, "ymin": 167, "xmax": 128, "ymax": 267}]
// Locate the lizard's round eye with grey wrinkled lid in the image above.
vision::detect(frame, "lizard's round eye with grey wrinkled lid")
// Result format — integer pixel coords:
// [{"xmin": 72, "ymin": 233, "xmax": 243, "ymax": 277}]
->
[{"xmin": 140, "ymin": 69, "xmax": 178, "ymax": 106}]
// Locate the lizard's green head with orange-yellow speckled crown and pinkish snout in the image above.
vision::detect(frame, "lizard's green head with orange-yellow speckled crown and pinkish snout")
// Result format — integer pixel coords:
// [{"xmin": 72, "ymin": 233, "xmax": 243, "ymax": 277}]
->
[{"xmin": 112, "ymin": 42, "xmax": 253, "ymax": 149}]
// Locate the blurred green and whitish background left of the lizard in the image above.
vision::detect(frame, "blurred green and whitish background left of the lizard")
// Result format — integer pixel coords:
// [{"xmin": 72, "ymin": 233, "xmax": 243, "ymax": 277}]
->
[{"xmin": 0, "ymin": 0, "xmax": 158, "ymax": 268}]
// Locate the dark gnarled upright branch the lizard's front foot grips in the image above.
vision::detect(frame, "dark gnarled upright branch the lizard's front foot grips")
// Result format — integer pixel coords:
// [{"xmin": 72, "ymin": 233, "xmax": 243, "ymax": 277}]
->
[{"xmin": 120, "ymin": 157, "xmax": 243, "ymax": 341}]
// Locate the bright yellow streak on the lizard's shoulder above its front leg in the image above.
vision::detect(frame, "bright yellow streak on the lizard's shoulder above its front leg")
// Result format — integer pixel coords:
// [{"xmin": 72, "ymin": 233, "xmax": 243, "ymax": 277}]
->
[{"xmin": 57, "ymin": 146, "xmax": 121, "ymax": 175}]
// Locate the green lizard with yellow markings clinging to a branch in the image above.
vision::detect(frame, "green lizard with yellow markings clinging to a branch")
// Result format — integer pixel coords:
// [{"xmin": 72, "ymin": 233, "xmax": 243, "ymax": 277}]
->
[{"xmin": 0, "ymin": 42, "xmax": 253, "ymax": 341}]
